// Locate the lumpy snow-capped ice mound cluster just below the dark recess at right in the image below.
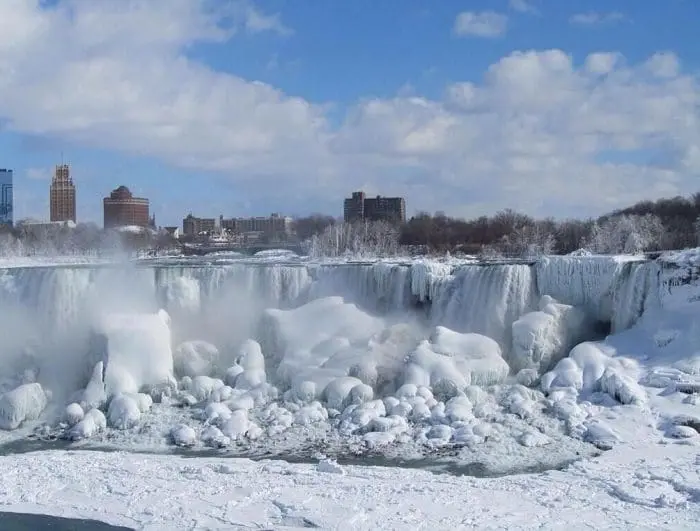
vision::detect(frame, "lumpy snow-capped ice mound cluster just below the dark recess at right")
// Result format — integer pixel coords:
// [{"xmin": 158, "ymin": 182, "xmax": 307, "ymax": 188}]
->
[{"xmin": 540, "ymin": 342, "xmax": 647, "ymax": 405}]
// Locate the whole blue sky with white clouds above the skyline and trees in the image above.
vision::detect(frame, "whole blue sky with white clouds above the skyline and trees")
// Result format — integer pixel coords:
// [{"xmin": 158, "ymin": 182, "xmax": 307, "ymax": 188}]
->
[{"xmin": 0, "ymin": 0, "xmax": 700, "ymax": 225}]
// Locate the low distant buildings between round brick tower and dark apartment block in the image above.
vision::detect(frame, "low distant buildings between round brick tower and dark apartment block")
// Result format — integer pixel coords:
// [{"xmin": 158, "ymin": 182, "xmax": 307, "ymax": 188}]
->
[{"xmin": 182, "ymin": 214, "xmax": 292, "ymax": 243}]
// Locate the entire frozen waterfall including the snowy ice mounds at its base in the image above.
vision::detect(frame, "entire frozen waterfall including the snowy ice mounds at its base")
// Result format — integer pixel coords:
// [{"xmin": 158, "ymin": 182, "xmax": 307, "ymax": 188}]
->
[{"xmin": 0, "ymin": 248, "xmax": 700, "ymax": 482}]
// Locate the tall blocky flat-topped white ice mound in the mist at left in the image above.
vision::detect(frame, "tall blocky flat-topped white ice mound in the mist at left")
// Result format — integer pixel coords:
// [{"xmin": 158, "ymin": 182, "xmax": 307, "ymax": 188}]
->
[{"xmin": 96, "ymin": 310, "xmax": 175, "ymax": 397}]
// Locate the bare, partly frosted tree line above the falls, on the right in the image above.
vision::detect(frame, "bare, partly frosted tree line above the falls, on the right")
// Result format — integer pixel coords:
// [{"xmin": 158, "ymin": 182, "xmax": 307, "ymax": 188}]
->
[{"xmin": 295, "ymin": 192, "xmax": 700, "ymax": 257}]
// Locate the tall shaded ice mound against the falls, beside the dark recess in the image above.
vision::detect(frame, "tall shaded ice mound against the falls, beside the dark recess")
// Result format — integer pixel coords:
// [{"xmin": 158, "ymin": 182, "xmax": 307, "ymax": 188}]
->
[{"xmin": 510, "ymin": 296, "xmax": 590, "ymax": 374}]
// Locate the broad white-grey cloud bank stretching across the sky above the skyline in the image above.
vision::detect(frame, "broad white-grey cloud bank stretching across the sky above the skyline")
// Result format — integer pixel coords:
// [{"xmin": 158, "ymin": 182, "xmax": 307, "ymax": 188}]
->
[{"xmin": 0, "ymin": 0, "xmax": 700, "ymax": 216}]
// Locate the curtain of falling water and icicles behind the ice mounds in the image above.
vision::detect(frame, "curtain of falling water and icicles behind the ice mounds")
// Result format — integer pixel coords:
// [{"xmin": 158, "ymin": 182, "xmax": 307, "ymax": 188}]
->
[{"xmin": 0, "ymin": 257, "xmax": 672, "ymax": 400}]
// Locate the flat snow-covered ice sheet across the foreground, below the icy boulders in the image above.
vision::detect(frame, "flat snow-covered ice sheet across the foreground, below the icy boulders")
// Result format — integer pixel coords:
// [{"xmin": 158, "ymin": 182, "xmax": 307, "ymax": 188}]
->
[{"xmin": 0, "ymin": 443, "xmax": 700, "ymax": 531}]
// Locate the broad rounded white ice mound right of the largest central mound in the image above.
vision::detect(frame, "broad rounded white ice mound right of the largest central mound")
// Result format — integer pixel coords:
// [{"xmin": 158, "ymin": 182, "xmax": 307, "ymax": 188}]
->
[{"xmin": 404, "ymin": 326, "xmax": 509, "ymax": 397}]
